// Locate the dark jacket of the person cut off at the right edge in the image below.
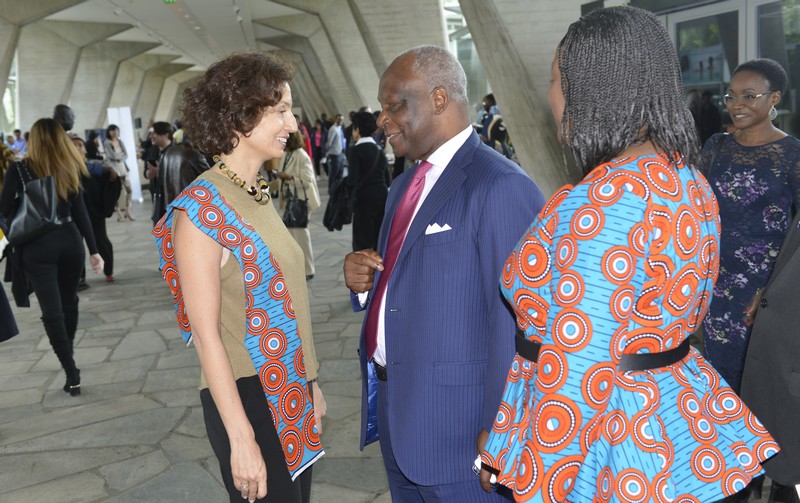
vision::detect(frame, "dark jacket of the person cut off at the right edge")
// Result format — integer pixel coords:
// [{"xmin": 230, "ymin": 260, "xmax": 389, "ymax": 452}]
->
[{"xmin": 742, "ymin": 214, "xmax": 800, "ymax": 485}]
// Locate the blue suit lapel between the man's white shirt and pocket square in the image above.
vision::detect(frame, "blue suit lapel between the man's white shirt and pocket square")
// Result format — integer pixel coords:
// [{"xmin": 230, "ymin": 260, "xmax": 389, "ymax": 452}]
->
[{"xmin": 392, "ymin": 132, "xmax": 480, "ymax": 269}]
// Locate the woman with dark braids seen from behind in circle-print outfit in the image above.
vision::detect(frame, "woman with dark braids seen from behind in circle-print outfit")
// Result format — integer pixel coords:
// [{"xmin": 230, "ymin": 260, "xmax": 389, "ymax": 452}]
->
[{"xmin": 479, "ymin": 7, "xmax": 778, "ymax": 503}]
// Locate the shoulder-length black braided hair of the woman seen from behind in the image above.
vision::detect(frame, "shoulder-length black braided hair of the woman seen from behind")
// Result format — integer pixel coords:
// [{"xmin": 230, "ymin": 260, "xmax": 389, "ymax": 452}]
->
[{"xmin": 558, "ymin": 7, "xmax": 699, "ymax": 174}]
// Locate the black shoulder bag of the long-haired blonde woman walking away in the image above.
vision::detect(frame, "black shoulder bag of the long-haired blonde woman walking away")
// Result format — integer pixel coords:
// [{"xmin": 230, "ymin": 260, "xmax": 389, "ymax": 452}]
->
[{"xmin": 8, "ymin": 162, "xmax": 68, "ymax": 246}]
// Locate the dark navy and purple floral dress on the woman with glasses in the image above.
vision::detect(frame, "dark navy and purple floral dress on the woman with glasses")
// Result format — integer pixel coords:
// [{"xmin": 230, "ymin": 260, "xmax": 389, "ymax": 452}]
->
[{"xmin": 702, "ymin": 134, "xmax": 800, "ymax": 393}]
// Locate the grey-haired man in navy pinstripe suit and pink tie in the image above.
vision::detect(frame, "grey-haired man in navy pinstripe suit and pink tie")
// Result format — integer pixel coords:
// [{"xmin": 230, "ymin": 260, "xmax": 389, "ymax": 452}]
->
[{"xmin": 344, "ymin": 46, "xmax": 544, "ymax": 502}]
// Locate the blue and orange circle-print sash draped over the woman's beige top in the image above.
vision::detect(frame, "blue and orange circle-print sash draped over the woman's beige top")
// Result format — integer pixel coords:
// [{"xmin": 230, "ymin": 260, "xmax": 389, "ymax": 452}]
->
[{"xmin": 153, "ymin": 174, "xmax": 323, "ymax": 480}]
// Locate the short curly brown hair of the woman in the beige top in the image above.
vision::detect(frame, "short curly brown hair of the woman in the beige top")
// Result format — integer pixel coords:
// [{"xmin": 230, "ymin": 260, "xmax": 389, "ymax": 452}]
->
[{"xmin": 181, "ymin": 52, "xmax": 294, "ymax": 154}]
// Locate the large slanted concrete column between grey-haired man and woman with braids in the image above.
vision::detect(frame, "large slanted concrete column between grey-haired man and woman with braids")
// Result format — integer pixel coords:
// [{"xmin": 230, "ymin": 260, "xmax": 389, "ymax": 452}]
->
[{"xmin": 459, "ymin": 0, "xmax": 582, "ymax": 196}]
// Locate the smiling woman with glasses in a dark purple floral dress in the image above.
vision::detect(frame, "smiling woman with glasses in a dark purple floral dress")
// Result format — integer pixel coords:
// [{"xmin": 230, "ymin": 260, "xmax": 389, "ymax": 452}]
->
[{"xmin": 702, "ymin": 59, "xmax": 800, "ymax": 393}]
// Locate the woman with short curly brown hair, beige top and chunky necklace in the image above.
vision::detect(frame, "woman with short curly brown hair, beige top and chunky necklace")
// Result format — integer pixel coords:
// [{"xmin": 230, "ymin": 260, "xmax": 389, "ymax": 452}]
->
[{"xmin": 153, "ymin": 53, "xmax": 325, "ymax": 503}]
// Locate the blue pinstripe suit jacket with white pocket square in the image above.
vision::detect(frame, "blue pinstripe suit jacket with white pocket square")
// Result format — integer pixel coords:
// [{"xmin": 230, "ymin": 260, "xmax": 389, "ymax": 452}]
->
[{"xmin": 353, "ymin": 132, "xmax": 544, "ymax": 485}]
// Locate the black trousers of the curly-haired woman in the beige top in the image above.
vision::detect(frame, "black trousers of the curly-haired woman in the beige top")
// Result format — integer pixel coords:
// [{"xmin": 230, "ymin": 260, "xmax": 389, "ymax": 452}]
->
[{"xmin": 200, "ymin": 376, "xmax": 312, "ymax": 503}]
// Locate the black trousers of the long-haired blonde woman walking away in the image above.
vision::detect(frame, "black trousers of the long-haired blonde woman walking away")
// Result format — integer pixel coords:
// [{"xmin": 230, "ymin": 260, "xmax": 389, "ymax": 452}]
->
[{"xmin": 21, "ymin": 222, "xmax": 84, "ymax": 374}]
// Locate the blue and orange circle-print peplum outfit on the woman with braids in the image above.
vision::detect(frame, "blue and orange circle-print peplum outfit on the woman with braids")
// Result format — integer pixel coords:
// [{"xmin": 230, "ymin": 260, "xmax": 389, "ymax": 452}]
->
[{"xmin": 482, "ymin": 156, "xmax": 778, "ymax": 502}]
